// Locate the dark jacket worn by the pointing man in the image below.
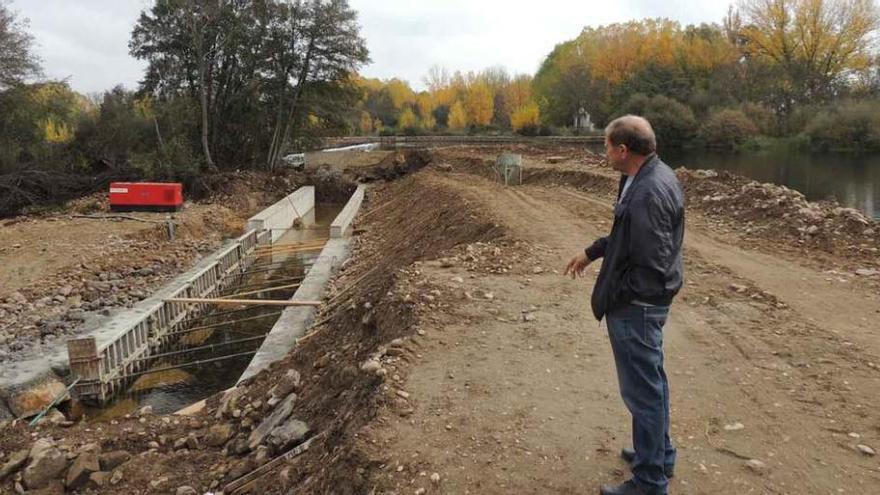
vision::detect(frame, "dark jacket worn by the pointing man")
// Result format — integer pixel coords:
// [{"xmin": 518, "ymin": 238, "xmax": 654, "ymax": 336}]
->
[{"xmin": 586, "ymin": 155, "xmax": 684, "ymax": 320}]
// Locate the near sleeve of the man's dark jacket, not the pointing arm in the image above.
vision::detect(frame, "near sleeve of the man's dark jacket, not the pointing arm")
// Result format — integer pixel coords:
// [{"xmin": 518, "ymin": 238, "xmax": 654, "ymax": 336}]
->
[{"xmin": 622, "ymin": 195, "xmax": 676, "ymax": 297}]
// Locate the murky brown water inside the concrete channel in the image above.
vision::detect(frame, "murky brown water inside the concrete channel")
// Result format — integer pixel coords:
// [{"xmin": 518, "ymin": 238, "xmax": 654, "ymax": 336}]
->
[{"xmin": 85, "ymin": 204, "xmax": 342, "ymax": 420}]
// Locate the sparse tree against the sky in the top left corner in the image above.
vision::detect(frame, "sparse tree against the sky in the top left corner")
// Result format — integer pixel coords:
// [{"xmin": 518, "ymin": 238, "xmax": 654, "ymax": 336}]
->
[{"xmin": 0, "ymin": 1, "xmax": 40, "ymax": 90}]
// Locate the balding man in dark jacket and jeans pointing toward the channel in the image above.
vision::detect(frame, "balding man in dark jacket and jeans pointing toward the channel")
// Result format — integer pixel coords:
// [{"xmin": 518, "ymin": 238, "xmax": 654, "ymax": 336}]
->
[{"xmin": 565, "ymin": 115, "xmax": 684, "ymax": 495}]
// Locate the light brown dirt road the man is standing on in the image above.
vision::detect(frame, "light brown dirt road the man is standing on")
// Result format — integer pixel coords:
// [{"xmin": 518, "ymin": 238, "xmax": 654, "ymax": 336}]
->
[{"xmin": 369, "ymin": 169, "xmax": 880, "ymax": 494}]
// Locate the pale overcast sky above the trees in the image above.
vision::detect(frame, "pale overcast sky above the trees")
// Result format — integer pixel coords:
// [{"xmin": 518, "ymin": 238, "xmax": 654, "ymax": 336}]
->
[{"xmin": 7, "ymin": 0, "xmax": 730, "ymax": 93}]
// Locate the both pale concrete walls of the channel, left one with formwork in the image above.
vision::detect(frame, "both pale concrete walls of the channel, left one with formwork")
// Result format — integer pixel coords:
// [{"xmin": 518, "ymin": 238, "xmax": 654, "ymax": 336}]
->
[{"xmin": 0, "ymin": 186, "xmax": 365, "ymax": 419}]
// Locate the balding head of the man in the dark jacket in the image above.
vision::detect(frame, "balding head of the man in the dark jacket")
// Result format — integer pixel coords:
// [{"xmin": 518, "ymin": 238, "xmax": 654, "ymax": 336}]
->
[{"xmin": 605, "ymin": 115, "xmax": 657, "ymax": 175}]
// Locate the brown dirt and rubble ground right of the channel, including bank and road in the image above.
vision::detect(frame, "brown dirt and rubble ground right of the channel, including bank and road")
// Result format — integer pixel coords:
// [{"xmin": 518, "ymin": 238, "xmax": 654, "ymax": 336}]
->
[{"xmin": 0, "ymin": 147, "xmax": 880, "ymax": 494}]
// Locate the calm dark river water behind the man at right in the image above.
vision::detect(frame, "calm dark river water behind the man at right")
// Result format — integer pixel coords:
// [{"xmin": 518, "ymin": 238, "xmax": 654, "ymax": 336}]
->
[{"xmin": 661, "ymin": 150, "xmax": 880, "ymax": 219}]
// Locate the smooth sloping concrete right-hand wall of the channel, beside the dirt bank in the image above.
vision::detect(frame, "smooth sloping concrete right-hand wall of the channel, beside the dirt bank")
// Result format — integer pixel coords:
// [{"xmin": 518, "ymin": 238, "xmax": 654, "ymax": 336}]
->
[{"xmin": 239, "ymin": 185, "xmax": 366, "ymax": 383}]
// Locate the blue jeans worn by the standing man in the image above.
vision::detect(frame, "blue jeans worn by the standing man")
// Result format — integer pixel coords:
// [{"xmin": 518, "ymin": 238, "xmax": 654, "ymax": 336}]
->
[{"xmin": 606, "ymin": 304, "xmax": 675, "ymax": 495}]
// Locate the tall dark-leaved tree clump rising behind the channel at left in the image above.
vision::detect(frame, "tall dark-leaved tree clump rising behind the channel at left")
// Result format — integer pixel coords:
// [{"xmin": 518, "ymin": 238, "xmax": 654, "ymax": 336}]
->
[{"xmin": 129, "ymin": 0, "xmax": 368, "ymax": 169}]
